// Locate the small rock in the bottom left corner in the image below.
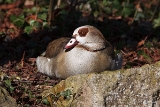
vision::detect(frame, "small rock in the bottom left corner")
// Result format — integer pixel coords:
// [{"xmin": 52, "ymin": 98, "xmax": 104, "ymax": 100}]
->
[{"xmin": 0, "ymin": 87, "xmax": 17, "ymax": 107}]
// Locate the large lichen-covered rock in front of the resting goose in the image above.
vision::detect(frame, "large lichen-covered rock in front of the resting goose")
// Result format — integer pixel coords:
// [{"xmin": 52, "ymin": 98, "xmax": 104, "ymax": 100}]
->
[{"xmin": 42, "ymin": 62, "xmax": 160, "ymax": 107}]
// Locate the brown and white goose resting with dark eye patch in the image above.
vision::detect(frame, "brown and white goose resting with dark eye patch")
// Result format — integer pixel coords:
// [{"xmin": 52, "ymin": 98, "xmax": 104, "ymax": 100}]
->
[{"xmin": 36, "ymin": 25, "xmax": 122, "ymax": 79}]
